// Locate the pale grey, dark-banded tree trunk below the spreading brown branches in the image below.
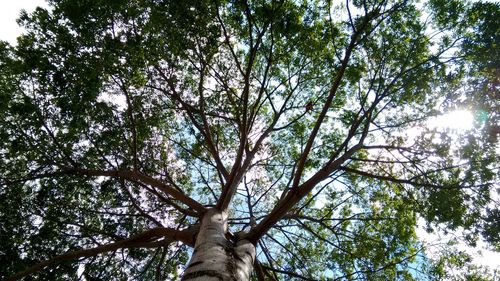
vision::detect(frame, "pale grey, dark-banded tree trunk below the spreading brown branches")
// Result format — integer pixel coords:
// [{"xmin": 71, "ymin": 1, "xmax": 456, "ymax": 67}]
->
[{"xmin": 182, "ymin": 209, "xmax": 255, "ymax": 281}]
